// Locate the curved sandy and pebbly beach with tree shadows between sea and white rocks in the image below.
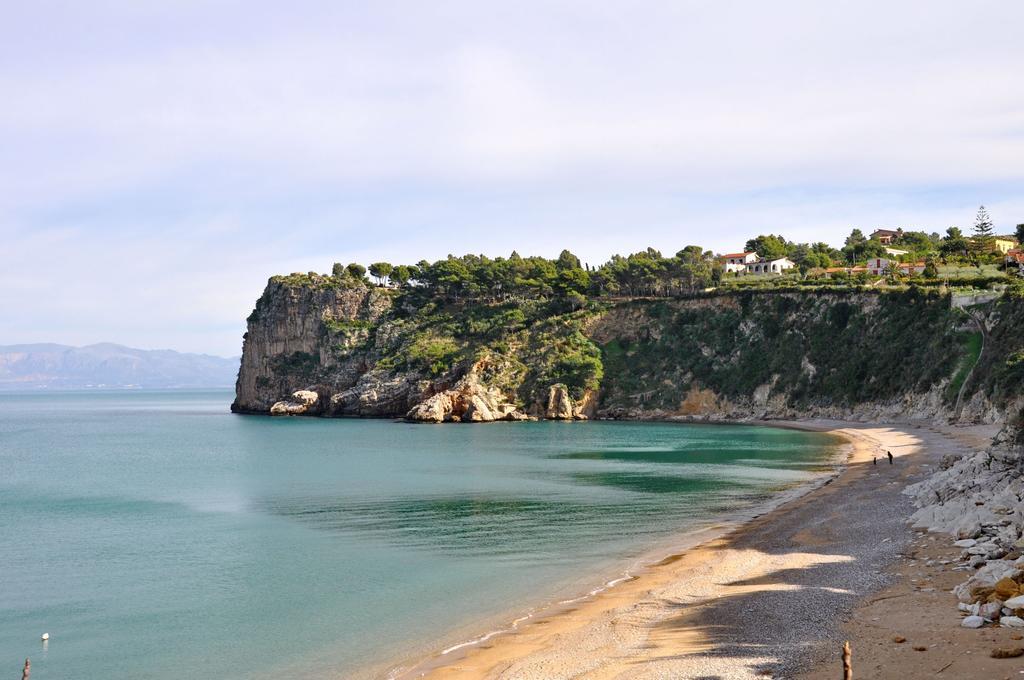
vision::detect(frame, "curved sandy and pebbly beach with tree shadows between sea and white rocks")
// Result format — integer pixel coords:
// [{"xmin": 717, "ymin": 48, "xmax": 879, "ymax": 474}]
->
[{"xmin": 391, "ymin": 420, "xmax": 996, "ymax": 680}]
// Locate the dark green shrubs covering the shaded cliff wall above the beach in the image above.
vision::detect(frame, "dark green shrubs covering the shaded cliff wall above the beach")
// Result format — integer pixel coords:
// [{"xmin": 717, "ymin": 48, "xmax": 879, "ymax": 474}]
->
[{"xmin": 602, "ymin": 290, "xmax": 959, "ymax": 410}]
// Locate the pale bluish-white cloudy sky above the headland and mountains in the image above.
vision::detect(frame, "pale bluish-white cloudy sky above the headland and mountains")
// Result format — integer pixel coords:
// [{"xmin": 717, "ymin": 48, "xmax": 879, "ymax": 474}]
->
[{"xmin": 0, "ymin": 0, "xmax": 1024, "ymax": 355}]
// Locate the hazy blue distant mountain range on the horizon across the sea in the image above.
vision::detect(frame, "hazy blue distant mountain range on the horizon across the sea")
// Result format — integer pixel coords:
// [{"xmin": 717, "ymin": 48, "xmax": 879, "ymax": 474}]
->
[{"xmin": 0, "ymin": 342, "xmax": 239, "ymax": 390}]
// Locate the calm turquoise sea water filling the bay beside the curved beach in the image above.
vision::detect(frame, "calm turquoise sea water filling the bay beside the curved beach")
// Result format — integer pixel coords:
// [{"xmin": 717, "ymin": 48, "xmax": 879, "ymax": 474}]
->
[{"xmin": 0, "ymin": 391, "xmax": 838, "ymax": 680}]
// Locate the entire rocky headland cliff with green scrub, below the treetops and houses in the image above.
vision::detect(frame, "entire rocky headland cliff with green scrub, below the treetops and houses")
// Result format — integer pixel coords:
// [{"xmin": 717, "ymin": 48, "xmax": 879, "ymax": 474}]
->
[{"xmin": 232, "ymin": 274, "xmax": 1024, "ymax": 422}]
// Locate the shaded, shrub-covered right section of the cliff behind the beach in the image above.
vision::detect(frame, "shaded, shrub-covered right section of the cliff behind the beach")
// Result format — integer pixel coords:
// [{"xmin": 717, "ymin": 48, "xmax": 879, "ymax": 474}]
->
[{"xmin": 592, "ymin": 290, "xmax": 1024, "ymax": 423}]
